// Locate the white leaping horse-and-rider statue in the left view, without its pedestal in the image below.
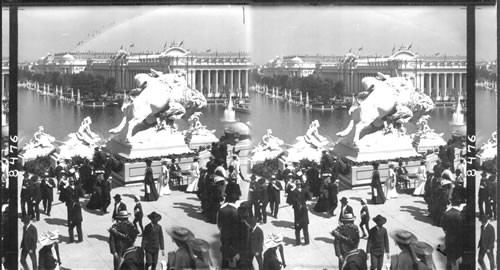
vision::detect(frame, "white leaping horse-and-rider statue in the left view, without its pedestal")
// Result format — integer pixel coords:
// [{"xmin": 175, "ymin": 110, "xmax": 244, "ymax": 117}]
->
[{"xmin": 109, "ymin": 69, "xmax": 207, "ymax": 142}]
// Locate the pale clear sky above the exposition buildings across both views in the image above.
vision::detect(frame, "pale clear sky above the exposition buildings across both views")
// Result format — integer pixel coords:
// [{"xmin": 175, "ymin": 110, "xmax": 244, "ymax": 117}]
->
[{"xmin": 2, "ymin": 5, "xmax": 497, "ymax": 64}]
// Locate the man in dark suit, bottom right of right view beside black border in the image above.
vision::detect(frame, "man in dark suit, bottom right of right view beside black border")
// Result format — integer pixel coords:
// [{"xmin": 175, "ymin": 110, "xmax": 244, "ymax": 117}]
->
[{"xmin": 440, "ymin": 198, "xmax": 464, "ymax": 270}]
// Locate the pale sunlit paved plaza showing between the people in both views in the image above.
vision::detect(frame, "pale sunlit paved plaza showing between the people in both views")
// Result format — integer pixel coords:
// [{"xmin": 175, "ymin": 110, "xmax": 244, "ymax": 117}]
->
[{"xmin": 18, "ymin": 171, "xmax": 496, "ymax": 269}]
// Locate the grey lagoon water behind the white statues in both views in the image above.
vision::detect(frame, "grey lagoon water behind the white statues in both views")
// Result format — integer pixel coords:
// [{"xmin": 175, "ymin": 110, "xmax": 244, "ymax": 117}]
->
[{"xmin": 18, "ymin": 88, "xmax": 497, "ymax": 147}]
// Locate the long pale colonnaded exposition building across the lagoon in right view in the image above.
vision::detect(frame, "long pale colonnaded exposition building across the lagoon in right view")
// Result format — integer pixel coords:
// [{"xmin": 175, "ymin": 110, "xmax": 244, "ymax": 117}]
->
[{"xmin": 260, "ymin": 48, "xmax": 467, "ymax": 101}]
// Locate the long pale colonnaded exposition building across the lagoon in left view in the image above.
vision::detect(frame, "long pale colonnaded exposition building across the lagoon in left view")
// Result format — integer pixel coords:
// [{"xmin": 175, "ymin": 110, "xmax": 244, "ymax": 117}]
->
[{"xmin": 32, "ymin": 43, "xmax": 254, "ymax": 98}]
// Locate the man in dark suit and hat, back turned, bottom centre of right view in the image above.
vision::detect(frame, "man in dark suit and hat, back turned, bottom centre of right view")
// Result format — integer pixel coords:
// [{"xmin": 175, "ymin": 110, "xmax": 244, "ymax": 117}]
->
[{"xmin": 366, "ymin": 215, "xmax": 389, "ymax": 270}]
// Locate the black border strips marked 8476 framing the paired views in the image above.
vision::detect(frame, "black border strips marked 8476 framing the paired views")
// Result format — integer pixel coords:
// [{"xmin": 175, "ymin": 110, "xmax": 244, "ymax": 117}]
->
[{"xmin": 2, "ymin": 0, "xmax": 500, "ymax": 269}]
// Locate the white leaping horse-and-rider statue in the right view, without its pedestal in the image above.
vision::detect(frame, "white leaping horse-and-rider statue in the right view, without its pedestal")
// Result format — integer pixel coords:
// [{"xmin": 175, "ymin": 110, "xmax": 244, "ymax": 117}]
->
[{"xmin": 337, "ymin": 73, "xmax": 434, "ymax": 145}]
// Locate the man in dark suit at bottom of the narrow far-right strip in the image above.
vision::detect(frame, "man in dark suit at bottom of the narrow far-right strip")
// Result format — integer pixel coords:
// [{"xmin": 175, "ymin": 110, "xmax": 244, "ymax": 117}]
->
[{"xmin": 477, "ymin": 215, "xmax": 496, "ymax": 270}]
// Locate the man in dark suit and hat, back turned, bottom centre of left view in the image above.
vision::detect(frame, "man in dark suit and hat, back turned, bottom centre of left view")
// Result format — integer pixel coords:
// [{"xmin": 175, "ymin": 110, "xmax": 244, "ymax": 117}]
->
[{"xmin": 141, "ymin": 212, "xmax": 165, "ymax": 270}]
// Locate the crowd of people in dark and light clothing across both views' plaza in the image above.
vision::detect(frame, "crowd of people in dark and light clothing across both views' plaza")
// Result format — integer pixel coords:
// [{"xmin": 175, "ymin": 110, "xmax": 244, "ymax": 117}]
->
[{"xmin": 11, "ymin": 141, "xmax": 496, "ymax": 270}]
